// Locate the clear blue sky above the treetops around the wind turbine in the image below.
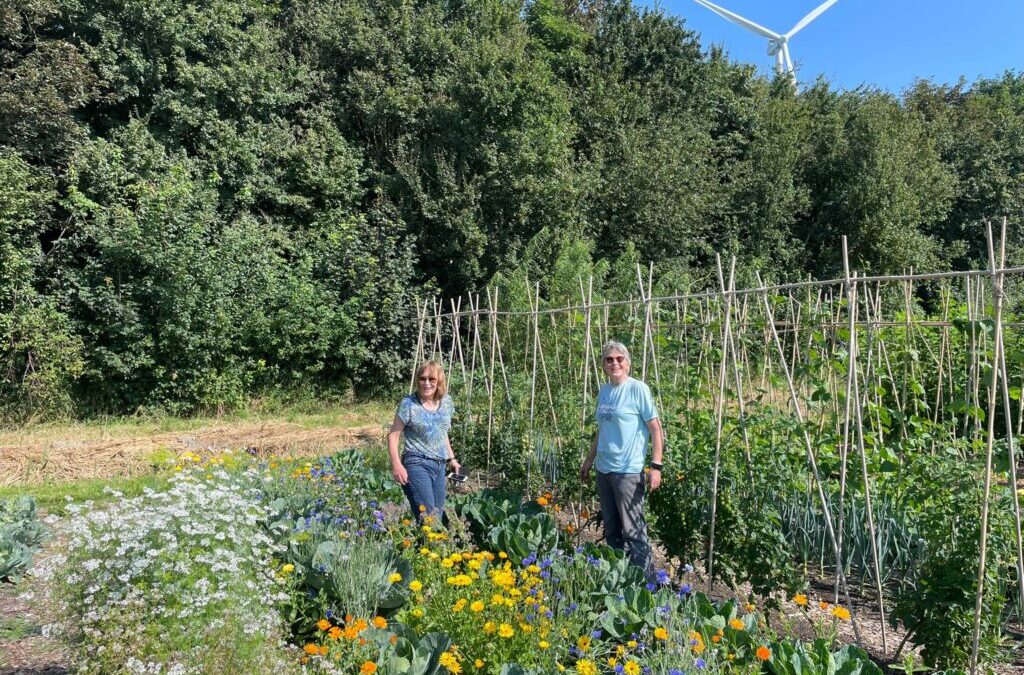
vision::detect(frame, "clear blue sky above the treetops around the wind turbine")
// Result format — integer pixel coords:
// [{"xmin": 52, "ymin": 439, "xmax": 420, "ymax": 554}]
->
[{"xmin": 647, "ymin": 0, "xmax": 1024, "ymax": 93}]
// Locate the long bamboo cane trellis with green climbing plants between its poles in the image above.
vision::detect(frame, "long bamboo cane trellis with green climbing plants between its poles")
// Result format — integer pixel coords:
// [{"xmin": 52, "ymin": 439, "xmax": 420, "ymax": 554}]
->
[{"xmin": 411, "ymin": 229, "xmax": 1024, "ymax": 673}]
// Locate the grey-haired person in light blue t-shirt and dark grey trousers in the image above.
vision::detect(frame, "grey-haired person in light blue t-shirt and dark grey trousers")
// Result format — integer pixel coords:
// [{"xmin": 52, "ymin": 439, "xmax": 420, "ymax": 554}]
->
[{"xmin": 580, "ymin": 341, "xmax": 665, "ymax": 579}]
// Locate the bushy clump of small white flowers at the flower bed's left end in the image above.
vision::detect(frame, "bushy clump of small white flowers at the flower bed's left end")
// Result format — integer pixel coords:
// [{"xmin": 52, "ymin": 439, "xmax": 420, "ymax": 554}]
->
[{"xmin": 49, "ymin": 469, "xmax": 288, "ymax": 675}]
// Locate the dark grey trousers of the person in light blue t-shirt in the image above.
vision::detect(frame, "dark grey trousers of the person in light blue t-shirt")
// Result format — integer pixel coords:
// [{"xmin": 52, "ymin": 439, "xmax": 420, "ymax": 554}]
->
[{"xmin": 597, "ymin": 471, "xmax": 654, "ymax": 580}]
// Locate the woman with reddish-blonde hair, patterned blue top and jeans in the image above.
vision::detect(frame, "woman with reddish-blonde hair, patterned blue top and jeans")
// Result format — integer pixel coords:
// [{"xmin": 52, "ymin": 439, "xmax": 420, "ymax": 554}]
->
[{"xmin": 387, "ymin": 361, "xmax": 462, "ymax": 518}]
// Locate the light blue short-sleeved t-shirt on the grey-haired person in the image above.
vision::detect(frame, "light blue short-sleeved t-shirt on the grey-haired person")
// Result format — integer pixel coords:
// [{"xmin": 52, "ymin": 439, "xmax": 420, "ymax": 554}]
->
[{"xmin": 595, "ymin": 377, "xmax": 657, "ymax": 473}]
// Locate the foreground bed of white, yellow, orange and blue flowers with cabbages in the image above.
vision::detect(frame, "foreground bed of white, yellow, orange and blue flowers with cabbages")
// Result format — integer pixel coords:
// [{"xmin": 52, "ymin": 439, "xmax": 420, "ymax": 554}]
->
[{"xmin": 34, "ymin": 448, "xmax": 880, "ymax": 675}]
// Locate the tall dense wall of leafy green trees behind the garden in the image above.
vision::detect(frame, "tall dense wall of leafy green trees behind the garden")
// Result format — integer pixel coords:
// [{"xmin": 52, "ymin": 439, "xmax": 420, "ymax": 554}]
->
[{"xmin": 0, "ymin": 0, "xmax": 1024, "ymax": 421}]
